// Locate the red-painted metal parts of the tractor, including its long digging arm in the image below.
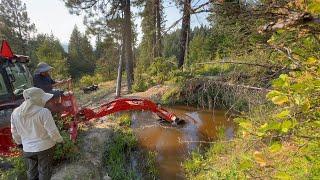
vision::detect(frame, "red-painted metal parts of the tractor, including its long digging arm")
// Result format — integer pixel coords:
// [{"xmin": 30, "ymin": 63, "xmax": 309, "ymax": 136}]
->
[{"xmin": 0, "ymin": 41, "xmax": 183, "ymax": 156}]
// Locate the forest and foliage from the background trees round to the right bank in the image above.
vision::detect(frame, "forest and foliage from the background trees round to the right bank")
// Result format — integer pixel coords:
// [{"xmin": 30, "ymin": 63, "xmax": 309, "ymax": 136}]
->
[{"xmin": 0, "ymin": 0, "xmax": 320, "ymax": 179}]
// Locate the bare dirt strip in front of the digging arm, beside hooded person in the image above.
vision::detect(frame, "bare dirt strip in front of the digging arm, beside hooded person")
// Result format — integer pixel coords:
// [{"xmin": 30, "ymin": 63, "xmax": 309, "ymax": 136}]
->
[{"xmin": 52, "ymin": 118, "xmax": 113, "ymax": 180}]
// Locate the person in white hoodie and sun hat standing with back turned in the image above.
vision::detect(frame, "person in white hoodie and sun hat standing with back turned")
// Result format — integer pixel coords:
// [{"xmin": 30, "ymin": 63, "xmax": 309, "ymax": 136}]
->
[{"xmin": 11, "ymin": 87, "xmax": 63, "ymax": 180}]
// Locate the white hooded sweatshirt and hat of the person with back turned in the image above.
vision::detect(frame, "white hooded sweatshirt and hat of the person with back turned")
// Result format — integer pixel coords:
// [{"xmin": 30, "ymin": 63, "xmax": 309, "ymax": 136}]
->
[{"xmin": 11, "ymin": 87, "xmax": 63, "ymax": 152}]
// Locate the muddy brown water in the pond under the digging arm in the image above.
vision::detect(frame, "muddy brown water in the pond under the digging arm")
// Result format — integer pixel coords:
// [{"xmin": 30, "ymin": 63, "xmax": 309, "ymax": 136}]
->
[{"xmin": 132, "ymin": 106, "xmax": 234, "ymax": 180}]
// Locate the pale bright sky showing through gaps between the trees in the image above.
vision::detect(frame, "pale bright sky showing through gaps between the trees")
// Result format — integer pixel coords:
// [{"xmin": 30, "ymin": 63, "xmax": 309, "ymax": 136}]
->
[{"xmin": 22, "ymin": 0, "xmax": 207, "ymax": 45}]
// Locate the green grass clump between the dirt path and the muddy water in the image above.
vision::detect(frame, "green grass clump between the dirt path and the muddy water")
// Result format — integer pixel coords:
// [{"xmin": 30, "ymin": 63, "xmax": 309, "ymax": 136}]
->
[{"xmin": 104, "ymin": 113, "xmax": 158, "ymax": 180}]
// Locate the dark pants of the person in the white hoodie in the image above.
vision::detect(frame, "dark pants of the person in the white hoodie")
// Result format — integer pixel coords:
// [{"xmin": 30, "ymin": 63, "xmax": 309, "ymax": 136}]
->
[{"xmin": 23, "ymin": 147, "xmax": 54, "ymax": 180}]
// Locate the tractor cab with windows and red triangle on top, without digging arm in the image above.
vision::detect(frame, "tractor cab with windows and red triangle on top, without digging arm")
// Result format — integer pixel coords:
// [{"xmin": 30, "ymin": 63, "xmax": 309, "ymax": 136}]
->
[{"xmin": 0, "ymin": 41, "xmax": 33, "ymax": 155}]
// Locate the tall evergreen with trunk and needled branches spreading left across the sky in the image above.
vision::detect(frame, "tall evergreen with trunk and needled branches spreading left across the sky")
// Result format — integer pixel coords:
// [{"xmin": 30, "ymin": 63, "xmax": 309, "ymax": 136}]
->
[{"xmin": 64, "ymin": 0, "xmax": 133, "ymax": 92}]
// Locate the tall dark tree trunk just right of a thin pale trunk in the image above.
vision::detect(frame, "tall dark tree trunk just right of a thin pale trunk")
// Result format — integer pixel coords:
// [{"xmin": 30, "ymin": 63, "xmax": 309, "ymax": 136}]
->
[{"xmin": 124, "ymin": 0, "xmax": 133, "ymax": 93}]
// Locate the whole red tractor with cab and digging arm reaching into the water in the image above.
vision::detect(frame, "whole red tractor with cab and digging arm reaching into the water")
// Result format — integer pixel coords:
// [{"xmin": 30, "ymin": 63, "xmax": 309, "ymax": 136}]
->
[{"xmin": 0, "ymin": 41, "xmax": 183, "ymax": 156}]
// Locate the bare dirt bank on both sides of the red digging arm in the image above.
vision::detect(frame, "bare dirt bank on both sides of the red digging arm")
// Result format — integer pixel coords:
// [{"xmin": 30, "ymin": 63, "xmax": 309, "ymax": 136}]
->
[{"xmin": 52, "ymin": 81, "xmax": 115, "ymax": 180}]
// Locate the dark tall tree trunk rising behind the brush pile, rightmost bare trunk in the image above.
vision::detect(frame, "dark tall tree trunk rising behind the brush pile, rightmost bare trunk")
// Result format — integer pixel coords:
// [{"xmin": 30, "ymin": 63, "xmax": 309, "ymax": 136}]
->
[{"xmin": 178, "ymin": 0, "xmax": 191, "ymax": 68}]
